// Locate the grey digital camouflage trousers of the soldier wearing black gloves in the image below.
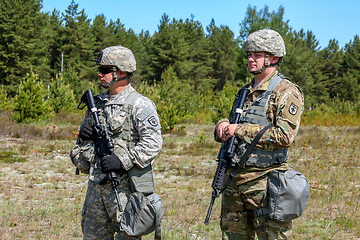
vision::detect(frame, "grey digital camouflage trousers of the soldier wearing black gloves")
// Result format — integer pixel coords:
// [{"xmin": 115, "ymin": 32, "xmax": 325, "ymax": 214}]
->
[{"xmin": 81, "ymin": 177, "xmax": 141, "ymax": 240}]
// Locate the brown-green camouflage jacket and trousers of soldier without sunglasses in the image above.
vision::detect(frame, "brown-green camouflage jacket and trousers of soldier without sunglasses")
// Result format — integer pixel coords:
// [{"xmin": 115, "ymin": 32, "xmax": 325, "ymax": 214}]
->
[{"xmin": 215, "ymin": 70, "xmax": 304, "ymax": 240}]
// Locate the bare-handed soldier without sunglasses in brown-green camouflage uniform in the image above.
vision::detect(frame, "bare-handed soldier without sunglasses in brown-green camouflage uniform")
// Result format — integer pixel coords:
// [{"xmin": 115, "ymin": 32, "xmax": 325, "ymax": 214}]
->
[{"xmin": 215, "ymin": 29, "xmax": 304, "ymax": 240}]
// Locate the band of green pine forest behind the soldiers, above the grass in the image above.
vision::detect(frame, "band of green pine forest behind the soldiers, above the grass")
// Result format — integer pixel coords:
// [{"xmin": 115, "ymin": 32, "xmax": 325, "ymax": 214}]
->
[{"xmin": 0, "ymin": 0, "xmax": 360, "ymax": 128}]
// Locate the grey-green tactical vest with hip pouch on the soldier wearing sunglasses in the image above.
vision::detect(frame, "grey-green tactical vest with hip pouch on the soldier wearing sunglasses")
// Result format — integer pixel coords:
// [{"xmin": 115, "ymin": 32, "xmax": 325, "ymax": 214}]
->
[{"xmin": 91, "ymin": 91, "xmax": 155, "ymax": 194}]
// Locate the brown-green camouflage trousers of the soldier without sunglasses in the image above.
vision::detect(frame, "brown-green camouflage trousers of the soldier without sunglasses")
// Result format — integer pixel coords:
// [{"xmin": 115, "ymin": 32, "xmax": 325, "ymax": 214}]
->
[{"xmin": 220, "ymin": 174, "xmax": 292, "ymax": 240}]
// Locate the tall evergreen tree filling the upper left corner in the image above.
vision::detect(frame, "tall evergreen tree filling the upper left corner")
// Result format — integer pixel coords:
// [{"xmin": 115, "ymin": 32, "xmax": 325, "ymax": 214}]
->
[{"xmin": 0, "ymin": 0, "xmax": 50, "ymax": 96}]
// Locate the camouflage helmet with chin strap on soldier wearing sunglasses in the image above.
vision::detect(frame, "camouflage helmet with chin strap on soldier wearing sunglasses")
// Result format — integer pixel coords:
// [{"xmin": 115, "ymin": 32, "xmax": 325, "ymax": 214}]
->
[{"xmin": 96, "ymin": 45, "xmax": 136, "ymax": 88}]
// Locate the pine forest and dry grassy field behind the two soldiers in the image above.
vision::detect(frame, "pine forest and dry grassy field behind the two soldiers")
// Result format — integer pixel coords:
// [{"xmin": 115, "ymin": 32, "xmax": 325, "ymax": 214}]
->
[{"xmin": 0, "ymin": 0, "xmax": 360, "ymax": 240}]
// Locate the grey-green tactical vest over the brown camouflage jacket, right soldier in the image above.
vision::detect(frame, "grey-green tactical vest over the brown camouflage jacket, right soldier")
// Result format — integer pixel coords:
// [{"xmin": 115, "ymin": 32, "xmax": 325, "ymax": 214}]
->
[{"xmin": 234, "ymin": 73, "xmax": 288, "ymax": 167}]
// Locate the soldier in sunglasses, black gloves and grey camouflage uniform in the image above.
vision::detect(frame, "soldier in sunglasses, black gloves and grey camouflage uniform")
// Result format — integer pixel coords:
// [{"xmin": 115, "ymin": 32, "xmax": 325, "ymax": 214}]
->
[{"xmin": 70, "ymin": 46, "xmax": 162, "ymax": 240}]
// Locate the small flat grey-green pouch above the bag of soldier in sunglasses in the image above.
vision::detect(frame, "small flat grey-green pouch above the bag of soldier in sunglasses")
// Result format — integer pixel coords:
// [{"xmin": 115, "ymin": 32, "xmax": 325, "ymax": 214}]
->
[{"xmin": 128, "ymin": 164, "xmax": 155, "ymax": 195}]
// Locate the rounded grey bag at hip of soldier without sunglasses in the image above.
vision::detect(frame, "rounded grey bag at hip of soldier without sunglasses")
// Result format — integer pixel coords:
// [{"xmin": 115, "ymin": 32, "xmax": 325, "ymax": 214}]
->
[{"xmin": 267, "ymin": 169, "xmax": 310, "ymax": 222}]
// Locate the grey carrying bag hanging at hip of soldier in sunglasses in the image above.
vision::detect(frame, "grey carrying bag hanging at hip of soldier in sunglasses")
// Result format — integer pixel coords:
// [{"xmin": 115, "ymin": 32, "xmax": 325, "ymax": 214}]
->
[{"xmin": 120, "ymin": 192, "xmax": 164, "ymax": 239}]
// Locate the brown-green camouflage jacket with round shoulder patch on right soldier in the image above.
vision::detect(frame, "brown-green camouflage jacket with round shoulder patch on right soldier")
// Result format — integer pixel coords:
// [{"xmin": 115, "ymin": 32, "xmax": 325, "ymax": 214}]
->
[{"xmin": 215, "ymin": 70, "xmax": 304, "ymax": 184}]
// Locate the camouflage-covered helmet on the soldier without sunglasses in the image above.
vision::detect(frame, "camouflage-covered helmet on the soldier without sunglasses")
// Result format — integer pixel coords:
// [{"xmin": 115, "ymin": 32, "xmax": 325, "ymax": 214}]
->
[{"xmin": 244, "ymin": 29, "xmax": 286, "ymax": 57}]
